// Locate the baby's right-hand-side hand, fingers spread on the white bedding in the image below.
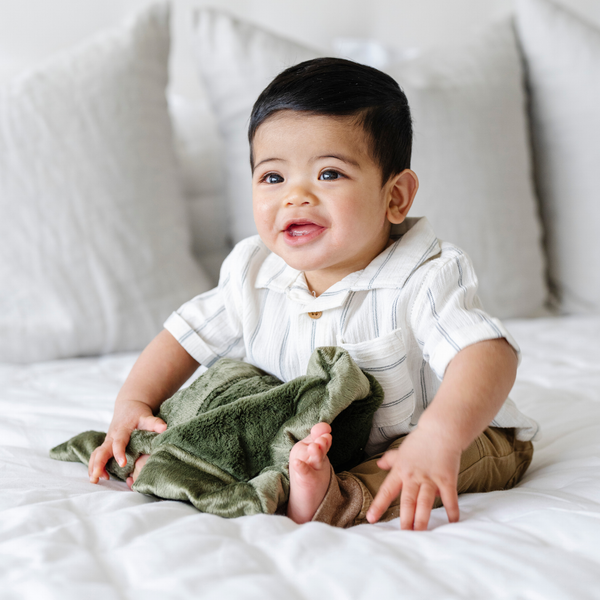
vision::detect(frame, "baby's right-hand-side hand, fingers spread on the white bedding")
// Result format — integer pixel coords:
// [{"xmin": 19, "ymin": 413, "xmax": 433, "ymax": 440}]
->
[{"xmin": 367, "ymin": 428, "xmax": 462, "ymax": 530}]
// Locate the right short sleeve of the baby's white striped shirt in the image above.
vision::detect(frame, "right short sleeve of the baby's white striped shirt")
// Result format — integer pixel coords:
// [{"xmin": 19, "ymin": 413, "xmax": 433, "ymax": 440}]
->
[{"xmin": 411, "ymin": 247, "xmax": 521, "ymax": 379}]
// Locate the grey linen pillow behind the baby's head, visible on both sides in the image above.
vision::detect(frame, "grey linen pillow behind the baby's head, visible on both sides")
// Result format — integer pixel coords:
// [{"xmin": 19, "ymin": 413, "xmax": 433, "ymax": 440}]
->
[{"xmin": 193, "ymin": 9, "xmax": 547, "ymax": 318}]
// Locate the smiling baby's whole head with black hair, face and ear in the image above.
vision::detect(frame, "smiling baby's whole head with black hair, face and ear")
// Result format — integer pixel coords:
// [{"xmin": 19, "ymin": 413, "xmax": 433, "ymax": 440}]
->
[{"xmin": 248, "ymin": 58, "xmax": 418, "ymax": 293}]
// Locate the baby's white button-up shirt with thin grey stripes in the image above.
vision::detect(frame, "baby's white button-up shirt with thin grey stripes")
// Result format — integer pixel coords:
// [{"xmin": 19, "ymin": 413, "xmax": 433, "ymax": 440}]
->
[{"xmin": 165, "ymin": 218, "xmax": 538, "ymax": 454}]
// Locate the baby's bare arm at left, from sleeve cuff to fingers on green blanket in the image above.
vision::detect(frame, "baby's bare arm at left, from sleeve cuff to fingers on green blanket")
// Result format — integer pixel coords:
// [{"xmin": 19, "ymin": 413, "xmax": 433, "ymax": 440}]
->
[{"xmin": 88, "ymin": 329, "xmax": 199, "ymax": 483}]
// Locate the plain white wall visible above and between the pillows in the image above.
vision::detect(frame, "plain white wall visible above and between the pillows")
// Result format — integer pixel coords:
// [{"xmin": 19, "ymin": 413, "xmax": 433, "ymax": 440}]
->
[{"xmin": 0, "ymin": 0, "xmax": 600, "ymax": 98}]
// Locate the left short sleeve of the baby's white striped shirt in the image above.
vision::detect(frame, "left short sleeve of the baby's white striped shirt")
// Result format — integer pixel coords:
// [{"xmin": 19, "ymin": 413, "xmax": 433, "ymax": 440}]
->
[{"xmin": 164, "ymin": 247, "xmax": 245, "ymax": 367}]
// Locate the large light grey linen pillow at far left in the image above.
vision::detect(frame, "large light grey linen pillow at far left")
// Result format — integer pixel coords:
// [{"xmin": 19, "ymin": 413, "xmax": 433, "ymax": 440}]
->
[{"xmin": 0, "ymin": 5, "xmax": 209, "ymax": 362}]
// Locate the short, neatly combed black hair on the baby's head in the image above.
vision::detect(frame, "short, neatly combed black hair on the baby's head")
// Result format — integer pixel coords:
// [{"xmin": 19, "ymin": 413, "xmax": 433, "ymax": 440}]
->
[{"xmin": 248, "ymin": 58, "xmax": 412, "ymax": 184}]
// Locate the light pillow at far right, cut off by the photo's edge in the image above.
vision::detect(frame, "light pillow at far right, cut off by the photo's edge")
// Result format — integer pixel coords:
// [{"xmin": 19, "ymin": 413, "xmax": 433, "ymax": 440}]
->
[{"xmin": 517, "ymin": 0, "xmax": 600, "ymax": 313}]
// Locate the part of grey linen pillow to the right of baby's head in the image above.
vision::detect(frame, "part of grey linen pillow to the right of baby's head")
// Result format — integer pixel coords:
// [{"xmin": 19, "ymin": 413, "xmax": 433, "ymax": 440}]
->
[{"xmin": 386, "ymin": 20, "xmax": 547, "ymax": 318}]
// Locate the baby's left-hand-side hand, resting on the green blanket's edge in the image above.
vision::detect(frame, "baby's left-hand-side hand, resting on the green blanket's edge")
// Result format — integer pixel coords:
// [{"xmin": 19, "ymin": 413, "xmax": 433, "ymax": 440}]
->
[{"xmin": 88, "ymin": 400, "xmax": 167, "ymax": 483}]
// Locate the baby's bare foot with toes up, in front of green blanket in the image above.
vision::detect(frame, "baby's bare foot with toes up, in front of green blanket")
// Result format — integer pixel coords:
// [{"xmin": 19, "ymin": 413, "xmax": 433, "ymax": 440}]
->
[{"xmin": 287, "ymin": 423, "xmax": 331, "ymax": 523}]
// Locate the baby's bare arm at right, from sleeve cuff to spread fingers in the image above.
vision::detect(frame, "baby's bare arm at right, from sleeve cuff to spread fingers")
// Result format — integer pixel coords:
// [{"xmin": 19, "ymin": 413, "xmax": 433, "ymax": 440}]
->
[{"xmin": 367, "ymin": 338, "xmax": 517, "ymax": 530}]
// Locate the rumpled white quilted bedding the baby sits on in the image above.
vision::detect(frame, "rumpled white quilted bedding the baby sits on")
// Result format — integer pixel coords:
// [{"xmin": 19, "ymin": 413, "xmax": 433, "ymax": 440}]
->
[{"xmin": 0, "ymin": 316, "xmax": 600, "ymax": 600}]
